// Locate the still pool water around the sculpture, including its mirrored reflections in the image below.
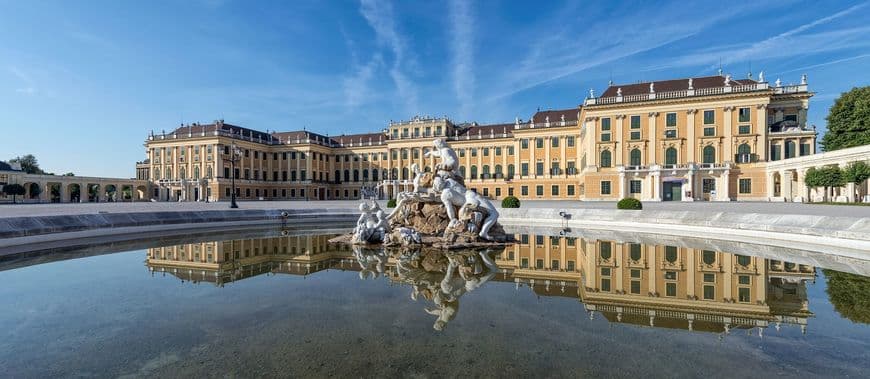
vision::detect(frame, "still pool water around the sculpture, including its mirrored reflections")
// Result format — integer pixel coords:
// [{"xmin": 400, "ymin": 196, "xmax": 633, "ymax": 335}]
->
[{"xmin": 0, "ymin": 230, "xmax": 870, "ymax": 377}]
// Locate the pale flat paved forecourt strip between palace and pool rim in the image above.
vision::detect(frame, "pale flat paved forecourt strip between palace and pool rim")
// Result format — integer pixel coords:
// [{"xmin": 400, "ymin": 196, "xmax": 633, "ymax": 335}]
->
[{"xmin": 0, "ymin": 200, "xmax": 870, "ymax": 218}]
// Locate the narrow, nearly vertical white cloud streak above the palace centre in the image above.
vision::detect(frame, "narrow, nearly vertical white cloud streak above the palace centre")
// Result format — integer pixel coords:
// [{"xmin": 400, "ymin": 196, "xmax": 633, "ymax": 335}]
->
[{"xmin": 449, "ymin": 0, "xmax": 475, "ymax": 119}]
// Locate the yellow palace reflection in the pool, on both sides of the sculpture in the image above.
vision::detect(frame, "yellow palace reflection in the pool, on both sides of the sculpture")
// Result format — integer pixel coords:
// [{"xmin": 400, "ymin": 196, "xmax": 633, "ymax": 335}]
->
[{"xmin": 147, "ymin": 234, "xmax": 815, "ymax": 333}]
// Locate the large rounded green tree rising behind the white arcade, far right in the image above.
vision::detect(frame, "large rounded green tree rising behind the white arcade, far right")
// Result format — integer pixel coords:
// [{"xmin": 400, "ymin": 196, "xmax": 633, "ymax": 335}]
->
[{"xmin": 822, "ymin": 86, "xmax": 870, "ymax": 151}]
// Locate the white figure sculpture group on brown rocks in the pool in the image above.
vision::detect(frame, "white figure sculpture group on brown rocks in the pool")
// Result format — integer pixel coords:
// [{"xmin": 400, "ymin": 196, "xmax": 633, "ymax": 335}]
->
[{"xmin": 334, "ymin": 139, "xmax": 510, "ymax": 249}]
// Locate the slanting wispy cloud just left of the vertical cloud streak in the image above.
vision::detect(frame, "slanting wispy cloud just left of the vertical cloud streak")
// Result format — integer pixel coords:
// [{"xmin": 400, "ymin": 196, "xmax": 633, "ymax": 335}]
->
[{"xmin": 360, "ymin": 0, "xmax": 420, "ymax": 114}]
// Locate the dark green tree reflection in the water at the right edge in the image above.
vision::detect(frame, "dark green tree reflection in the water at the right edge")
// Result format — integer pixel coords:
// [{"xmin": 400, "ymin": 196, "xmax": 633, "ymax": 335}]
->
[{"xmin": 822, "ymin": 269, "xmax": 870, "ymax": 324}]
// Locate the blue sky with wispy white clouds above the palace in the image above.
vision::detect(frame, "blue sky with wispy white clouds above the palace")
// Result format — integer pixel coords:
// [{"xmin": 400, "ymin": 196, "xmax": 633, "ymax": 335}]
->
[{"xmin": 0, "ymin": 0, "xmax": 870, "ymax": 177}]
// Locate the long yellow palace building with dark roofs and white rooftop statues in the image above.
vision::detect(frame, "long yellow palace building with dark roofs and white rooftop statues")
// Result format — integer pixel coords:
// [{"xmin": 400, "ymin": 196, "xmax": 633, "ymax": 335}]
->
[{"xmin": 136, "ymin": 75, "xmax": 816, "ymax": 205}]
